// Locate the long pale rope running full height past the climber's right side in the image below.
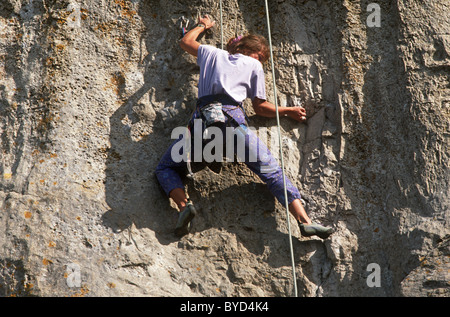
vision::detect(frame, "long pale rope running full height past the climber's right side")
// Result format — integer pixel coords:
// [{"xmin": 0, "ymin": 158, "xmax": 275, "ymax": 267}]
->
[{"xmin": 265, "ymin": 0, "xmax": 297, "ymax": 297}]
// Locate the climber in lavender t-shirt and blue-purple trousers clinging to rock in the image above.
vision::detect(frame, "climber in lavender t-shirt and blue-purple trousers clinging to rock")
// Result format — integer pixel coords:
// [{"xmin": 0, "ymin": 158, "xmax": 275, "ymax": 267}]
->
[{"xmin": 156, "ymin": 16, "xmax": 332, "ymax": 239}]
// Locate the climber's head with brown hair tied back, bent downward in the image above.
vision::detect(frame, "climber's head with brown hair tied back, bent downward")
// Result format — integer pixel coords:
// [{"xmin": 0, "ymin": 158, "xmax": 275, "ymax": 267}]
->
[{"xmin": 227, "ymin": 34, "xmax": 269, "ymax": 63}]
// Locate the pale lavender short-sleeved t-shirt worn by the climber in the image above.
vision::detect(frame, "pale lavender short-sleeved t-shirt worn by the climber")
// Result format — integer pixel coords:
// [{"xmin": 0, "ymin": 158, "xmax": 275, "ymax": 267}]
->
[{"xmin": 197, "ymin": 45, "xmax": 266, "ymax": 102}]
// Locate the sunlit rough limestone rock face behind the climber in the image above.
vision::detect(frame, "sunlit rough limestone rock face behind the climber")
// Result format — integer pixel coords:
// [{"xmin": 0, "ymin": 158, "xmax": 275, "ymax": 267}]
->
[{"xmin": 0, "ymin": 0, "xmax": 450, "ymax": 296}]
